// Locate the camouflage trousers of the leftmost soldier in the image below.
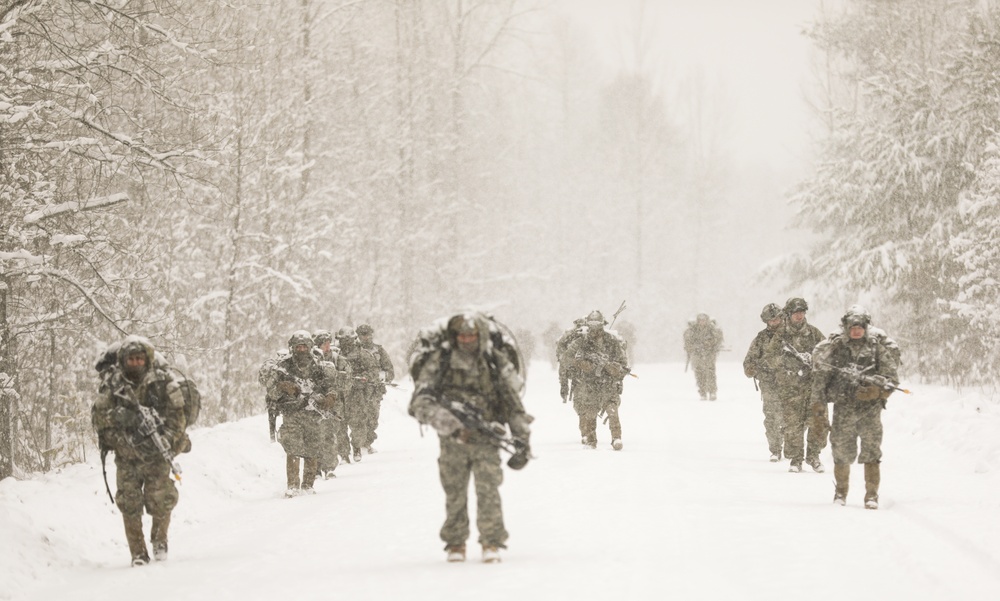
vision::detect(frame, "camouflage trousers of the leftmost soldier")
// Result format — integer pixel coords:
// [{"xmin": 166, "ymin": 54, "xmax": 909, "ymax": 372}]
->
[{"xmin": 115, "ymin": 453, "xmax": 180, "ymax": 517}]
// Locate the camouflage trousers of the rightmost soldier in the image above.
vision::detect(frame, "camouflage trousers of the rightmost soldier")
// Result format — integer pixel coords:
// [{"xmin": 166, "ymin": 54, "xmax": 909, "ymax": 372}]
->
[{"xmin": 830, "ymin": 401, "xmax": 882, "ymax": 465}]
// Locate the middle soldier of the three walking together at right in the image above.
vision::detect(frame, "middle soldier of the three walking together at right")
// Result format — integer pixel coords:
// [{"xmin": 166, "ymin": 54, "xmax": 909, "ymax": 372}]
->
[{"xmin": 764, "ymin": 297, "xmax": 830, "ymax": 473}]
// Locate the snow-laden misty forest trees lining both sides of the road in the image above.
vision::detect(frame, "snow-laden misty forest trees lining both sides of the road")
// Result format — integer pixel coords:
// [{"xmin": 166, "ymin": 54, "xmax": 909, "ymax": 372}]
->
[{"xmin": 0, "ymin": 0, "xmax": 1000, "ymax": 478}]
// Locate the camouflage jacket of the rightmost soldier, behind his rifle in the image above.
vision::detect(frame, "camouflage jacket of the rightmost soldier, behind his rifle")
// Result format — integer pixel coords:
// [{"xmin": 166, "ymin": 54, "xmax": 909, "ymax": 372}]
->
[{"xmin": 811, "ymin": 330, "xmax": 899, "ymax": 405}]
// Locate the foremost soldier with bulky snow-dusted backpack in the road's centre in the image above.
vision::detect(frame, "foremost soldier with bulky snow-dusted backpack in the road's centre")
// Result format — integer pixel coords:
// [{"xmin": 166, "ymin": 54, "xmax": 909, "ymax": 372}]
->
[{"xmin": 409, "ymin": 313, "xmax": 531, "ymax": 563}]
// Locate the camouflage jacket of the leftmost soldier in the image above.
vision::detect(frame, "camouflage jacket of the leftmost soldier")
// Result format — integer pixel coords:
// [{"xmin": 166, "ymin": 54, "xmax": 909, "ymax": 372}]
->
[{"xmin": 91, "ymin": 354, "xmax": 187, "ymax": 462}]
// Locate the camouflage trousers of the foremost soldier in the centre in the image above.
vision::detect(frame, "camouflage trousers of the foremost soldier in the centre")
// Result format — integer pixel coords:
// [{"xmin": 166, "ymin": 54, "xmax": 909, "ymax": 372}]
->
[{"xmin": 438, "ymin": 437, "xmax": 507, "ymax": 547}]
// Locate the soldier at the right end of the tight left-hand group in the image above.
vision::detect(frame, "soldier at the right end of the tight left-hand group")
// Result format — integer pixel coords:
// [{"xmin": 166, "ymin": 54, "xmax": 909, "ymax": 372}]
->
[{"xmin": 337, "ymin": 327, "xmax": 379, "ymax": 461}]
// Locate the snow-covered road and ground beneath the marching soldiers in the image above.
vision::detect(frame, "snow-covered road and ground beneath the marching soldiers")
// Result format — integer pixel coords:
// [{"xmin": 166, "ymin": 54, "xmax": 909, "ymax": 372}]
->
[{"xmin": 0, "ymin": 362, "xmax": 1000, "ymax": 601}]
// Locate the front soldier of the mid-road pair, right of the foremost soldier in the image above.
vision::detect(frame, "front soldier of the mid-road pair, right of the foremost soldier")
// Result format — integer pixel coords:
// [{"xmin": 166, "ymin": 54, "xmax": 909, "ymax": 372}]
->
[{"xmin": 564, "ymin": 311, "xmax": 629, "ymax": 451}]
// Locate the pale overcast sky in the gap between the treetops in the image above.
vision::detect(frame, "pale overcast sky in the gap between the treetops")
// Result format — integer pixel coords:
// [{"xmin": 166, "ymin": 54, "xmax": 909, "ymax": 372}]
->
[{"xmin": 563, "ymin": 0, "xmax": 833, "ymax": 169}]
